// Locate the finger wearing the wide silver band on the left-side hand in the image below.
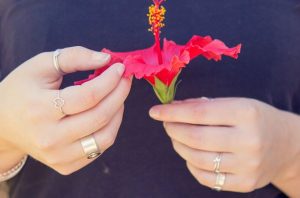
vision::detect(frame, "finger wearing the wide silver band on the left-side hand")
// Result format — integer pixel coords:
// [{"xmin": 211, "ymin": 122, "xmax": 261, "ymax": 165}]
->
[{"xmin": 50, "ymin": 106, "xmax": 124, "ymax": 166}]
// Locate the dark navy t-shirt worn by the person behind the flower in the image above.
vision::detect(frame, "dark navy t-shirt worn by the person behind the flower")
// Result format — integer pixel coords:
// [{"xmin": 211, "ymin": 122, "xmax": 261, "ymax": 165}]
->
[{"xmin": 0, "ymin": 0, "xmax": 300, "ymax": 198}]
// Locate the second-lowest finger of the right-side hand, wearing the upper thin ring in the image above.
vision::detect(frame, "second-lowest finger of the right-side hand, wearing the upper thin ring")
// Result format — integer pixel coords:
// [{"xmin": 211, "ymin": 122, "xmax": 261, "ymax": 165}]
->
[{"xmin": 172, "ymin": 140, "xmax": 237, "ymax": 173}]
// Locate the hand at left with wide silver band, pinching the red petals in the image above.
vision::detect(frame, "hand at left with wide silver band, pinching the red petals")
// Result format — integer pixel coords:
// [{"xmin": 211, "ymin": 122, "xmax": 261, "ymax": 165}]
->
[{"xmin": 0, "ymin": 47, "xmax": 131, "ymax": 175}]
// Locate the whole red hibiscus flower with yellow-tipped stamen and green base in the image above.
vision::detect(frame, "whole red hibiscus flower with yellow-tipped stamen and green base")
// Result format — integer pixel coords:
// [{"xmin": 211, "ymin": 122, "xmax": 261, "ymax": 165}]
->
[{"xmin": 75, "ymin": 0, "xmax": 241, "ymax": 103}]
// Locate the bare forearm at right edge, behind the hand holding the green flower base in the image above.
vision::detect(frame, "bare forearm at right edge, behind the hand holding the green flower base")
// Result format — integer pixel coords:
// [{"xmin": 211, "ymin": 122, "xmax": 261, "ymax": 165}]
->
[{"xmin": 272, "ymin": 110, "xmax": 300, "ymax": 197}]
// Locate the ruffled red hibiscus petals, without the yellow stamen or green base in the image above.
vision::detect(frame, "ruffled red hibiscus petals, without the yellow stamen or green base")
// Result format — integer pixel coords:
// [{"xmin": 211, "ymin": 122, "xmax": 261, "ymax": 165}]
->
[{"xmin": 75, "ymin": 36, "xmax": 241, "ymax": 85}]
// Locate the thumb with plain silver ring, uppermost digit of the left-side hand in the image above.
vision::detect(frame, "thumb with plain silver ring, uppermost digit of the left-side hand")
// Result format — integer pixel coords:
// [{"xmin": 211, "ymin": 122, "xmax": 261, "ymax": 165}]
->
[{"xmin": 30, "ymin": 46, "xmax": 110, "ymax": 82}]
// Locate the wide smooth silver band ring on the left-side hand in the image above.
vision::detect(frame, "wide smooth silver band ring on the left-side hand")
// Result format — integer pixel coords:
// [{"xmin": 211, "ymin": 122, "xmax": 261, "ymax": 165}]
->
[{"xmin": 80, "ymin": 135, "xmax": 102, "ymax": 159}]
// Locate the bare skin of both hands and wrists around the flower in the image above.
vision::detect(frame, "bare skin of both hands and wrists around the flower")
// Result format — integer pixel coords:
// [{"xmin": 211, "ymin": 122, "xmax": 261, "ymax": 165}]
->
[{"xmin": 0, "ymin": 47, "xmax": 300, "ymax": 197}]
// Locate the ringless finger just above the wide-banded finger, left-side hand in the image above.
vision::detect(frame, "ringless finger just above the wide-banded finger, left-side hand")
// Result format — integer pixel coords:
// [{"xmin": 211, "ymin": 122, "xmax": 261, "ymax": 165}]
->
[{"xmin": 53, "ymin": 78, "xmax": 131, "ymax": 142}]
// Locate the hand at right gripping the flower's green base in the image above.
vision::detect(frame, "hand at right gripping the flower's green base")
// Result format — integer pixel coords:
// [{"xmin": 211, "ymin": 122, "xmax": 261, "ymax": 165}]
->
[{"xmin": 150, "ymin": 98, "xmax": 296, "ymax": 192}]
